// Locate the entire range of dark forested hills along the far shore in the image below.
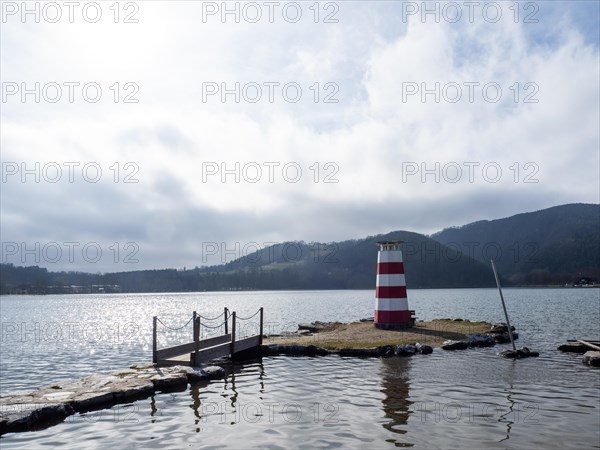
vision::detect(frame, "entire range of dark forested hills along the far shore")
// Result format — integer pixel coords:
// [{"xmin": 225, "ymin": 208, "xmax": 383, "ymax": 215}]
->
[{"xmin": 0, "ymin": 204, "xmax": 600, "ymax": 294}]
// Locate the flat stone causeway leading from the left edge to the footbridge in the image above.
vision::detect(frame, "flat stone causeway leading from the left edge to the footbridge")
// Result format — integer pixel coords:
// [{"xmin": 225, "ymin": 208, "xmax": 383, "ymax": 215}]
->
[{"xmin": 0, "ymin": 364, "xmax": 225, "ymax": 435}]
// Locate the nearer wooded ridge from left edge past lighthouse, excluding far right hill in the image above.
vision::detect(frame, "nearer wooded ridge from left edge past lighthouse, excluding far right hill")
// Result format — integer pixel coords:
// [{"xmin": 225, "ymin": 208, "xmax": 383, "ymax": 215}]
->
[{"xmin": 0, "ymin": 231, "xmax": 494, "ymax": 294}]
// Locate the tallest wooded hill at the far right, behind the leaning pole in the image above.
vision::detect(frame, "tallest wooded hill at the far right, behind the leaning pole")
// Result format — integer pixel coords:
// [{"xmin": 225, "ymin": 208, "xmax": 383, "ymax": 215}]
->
[{"xmin": 431, "ymin": 204, "xmax": 600, "ymax": 285}]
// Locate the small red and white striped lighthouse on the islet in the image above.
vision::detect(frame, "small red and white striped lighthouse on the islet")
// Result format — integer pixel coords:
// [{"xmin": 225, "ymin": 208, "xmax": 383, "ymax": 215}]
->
[{"xmin": 375, "ymin": 241, "xmax": 413, "ymax": 329}]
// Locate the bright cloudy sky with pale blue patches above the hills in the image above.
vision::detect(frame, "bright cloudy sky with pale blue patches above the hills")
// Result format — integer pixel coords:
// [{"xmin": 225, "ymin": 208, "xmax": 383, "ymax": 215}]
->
[{"xmin": 0, "ymin": 1, "xmax": 600, "ymax": 272}]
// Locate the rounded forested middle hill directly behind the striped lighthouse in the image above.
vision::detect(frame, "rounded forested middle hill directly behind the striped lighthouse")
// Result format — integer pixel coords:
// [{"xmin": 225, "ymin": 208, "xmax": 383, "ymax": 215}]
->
[{"xmin": 192, "ymin": 231, "xmax": 494, "ymax": 289}]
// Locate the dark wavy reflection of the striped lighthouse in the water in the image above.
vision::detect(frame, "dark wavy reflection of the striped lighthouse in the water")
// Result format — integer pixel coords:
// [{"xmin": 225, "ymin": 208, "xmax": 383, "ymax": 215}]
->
[{"xmin": 381, "ymin": 357, "xmax": 414, "ymax": 447}]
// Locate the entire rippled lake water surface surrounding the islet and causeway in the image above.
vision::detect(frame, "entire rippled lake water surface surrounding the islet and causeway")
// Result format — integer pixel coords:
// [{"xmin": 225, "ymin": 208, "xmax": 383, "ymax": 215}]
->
[{"xmin": 0, "ymin": 289, "xmax": 600, "ymax": 449}]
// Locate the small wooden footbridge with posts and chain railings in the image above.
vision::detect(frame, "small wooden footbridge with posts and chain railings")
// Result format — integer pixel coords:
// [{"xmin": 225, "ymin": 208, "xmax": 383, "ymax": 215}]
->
[{"xmin": 152, "ymin": 308, "xmax": 263, "ymax": 366}]
